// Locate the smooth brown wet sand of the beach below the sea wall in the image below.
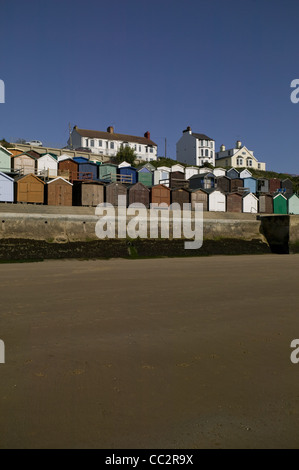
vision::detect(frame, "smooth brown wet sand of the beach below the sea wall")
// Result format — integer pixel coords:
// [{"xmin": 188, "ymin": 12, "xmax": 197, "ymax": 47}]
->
[{"xmin": 0, "ymin": 255, "xmax": 299, "ymax": 449}]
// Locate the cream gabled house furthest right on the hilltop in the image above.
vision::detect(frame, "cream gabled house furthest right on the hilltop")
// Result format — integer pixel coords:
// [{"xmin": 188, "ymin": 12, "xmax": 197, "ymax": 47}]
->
[{"xmin": 215, "ymin": 140, "xmax": 266, "ymax": 171}]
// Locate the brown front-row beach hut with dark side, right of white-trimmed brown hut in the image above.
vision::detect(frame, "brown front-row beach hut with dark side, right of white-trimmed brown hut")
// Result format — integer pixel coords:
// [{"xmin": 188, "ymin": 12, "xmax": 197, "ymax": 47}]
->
[{"xmin": 73, "ymin": 180, "xmax": 105, "ymax": 207}]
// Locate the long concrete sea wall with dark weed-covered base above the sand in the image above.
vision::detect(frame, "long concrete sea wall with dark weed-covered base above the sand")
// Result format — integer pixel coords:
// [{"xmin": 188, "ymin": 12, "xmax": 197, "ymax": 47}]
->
[{"xmin": 0, "ymin": 204, "xmax": 299, "ymax": 261}]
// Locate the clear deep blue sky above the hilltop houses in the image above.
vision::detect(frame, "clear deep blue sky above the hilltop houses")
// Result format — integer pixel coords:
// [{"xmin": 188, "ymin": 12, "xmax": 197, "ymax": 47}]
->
[{"xmin": 0, "ymin": 0, "xmax": 299, "ymax": 174}]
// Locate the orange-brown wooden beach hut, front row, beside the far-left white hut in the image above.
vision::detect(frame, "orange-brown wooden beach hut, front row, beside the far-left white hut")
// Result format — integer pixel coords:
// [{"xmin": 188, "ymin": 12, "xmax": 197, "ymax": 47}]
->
[{"xmin": 14, "ymin": 174, "xmax": 45, "ymax": 204}]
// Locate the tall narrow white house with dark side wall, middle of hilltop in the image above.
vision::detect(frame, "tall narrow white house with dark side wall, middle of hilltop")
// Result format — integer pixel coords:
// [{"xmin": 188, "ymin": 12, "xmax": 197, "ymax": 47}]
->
[{"xmin": 176, "ymin": 126, "xmax": 215, "ymax": 166}]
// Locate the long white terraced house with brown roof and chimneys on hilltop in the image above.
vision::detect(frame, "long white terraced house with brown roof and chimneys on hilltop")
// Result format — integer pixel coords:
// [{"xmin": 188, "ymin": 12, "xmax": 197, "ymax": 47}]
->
[{"xmin": 68, "ymin": 126, "xmax": 158, "ymax": 161}]
